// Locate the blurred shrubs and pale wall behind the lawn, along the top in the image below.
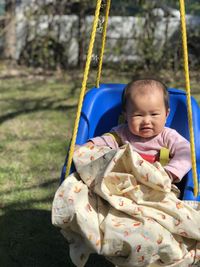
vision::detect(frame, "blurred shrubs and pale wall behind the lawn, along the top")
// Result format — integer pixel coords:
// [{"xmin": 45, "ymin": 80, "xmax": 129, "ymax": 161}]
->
[{"xmin": 1, "ymin": 0, "xmax": 200, "ymax": 70}]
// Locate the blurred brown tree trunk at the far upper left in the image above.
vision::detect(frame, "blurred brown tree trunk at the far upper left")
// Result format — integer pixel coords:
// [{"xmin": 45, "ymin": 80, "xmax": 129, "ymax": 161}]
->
[{"xmin": 4, "ymin": 0, "xmax": 16, "ymax": 62}]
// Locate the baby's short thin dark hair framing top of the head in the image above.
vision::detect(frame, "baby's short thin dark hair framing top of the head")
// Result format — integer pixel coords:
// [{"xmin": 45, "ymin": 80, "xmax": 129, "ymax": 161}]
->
[{"xmin": 122, "ymin": 78, "xmax": 169, "ymax": 111}]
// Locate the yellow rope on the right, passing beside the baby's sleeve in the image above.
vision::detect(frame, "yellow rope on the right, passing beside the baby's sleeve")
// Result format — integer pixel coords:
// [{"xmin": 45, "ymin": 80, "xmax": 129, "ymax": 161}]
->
[{"xmin": 179, "ymin": 0, "xmax": 198, "ymax": 197}]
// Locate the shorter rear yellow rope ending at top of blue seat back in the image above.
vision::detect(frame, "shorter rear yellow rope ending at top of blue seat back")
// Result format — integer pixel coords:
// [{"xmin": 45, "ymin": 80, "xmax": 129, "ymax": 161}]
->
[{"xmin": 96, "ymin": 0, "xmax": 111, "ymax": 88}]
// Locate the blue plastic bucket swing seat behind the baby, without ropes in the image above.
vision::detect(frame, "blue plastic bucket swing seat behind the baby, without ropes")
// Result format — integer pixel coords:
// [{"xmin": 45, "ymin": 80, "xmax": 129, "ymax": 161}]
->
[{"xmin": 61, "ymin": 84, "xmax": 200, "ymax": 201}]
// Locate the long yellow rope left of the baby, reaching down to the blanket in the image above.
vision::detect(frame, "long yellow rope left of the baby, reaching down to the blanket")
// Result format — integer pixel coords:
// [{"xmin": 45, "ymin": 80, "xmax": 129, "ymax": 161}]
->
[{"xmin": 65, "ymin": 0, "xmax": 101, "ymax": 178}]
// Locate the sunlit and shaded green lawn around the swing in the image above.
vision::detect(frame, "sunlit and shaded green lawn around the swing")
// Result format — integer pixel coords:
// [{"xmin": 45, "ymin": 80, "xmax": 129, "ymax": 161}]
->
[{"xmin": 0, "ymin": 67, "xmax": 200, "ymax": 267}]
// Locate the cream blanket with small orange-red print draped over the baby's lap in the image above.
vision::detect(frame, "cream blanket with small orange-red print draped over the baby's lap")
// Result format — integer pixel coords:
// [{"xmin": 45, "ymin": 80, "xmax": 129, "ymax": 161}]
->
[{"xmin": 52, "ymin": 144, "xmax": 200, "ymax": 267}]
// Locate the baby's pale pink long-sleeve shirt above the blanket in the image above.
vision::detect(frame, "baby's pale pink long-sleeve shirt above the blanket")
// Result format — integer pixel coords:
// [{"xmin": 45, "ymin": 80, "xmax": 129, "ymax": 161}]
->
[{"xmin": 90, "ymin": 124, "xmax": 191, "ymax": 182}]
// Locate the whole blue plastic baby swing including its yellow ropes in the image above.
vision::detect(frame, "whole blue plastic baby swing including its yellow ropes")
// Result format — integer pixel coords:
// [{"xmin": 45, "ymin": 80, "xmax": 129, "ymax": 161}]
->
[{"xmin": 61, "ymin": 0, "xmax": 200, "ymax": 201}]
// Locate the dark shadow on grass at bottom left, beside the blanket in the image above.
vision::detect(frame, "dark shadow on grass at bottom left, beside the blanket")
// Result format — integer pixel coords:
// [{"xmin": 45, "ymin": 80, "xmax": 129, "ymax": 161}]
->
[{"xmin": 0, "ymin": 209, "xmax": 113, "ymax": 267}]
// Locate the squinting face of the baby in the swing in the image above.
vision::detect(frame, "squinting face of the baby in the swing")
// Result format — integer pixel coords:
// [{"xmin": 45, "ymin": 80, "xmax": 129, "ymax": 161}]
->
[{"xmin": 125, "ymin": 86, "xmax": 169, "ymax": 138}]
